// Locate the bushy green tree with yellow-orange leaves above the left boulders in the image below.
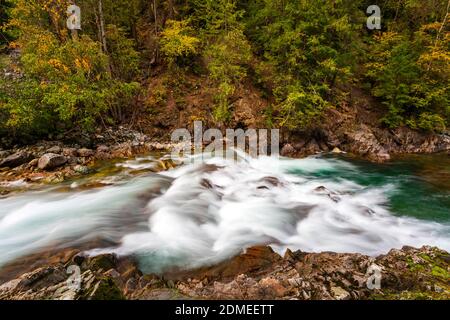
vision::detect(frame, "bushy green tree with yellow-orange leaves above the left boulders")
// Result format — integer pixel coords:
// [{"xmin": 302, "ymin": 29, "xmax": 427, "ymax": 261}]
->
[{"xmin": 2, "ymin": 32, "xmax": 139, "ymax": 134}]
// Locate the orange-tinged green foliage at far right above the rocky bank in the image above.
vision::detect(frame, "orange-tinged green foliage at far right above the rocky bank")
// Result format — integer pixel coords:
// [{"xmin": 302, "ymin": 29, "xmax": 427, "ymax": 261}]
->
[{"xmin": 366, "ymin": 24, "xmax": 450, "ymax": 132}]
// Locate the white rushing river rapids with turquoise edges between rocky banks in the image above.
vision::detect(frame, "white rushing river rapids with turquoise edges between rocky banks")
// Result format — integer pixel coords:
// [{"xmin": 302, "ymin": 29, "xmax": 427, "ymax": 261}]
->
[{"xmin": 0, "ymin": 155, "xmax": 450, "ymax": 272}]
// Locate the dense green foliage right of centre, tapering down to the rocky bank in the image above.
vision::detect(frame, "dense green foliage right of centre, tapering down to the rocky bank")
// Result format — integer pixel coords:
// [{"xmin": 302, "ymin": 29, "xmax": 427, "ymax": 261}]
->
[{"xmin": 247, "ymin": 0, "xmax": 362, "ymax": 129}]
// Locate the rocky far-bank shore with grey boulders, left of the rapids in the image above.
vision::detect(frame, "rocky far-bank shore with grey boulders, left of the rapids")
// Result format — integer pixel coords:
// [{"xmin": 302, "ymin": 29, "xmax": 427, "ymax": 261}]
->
[{"xmin": 0, "ymin": 127, "xmax": 179, "ymax": 195}]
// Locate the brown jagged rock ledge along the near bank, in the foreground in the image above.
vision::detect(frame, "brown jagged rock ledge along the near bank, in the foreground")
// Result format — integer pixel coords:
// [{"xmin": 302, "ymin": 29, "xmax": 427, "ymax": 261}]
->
[{"xmin": 0, "ymin": 247, "xmax": 450, "ymax": 300}]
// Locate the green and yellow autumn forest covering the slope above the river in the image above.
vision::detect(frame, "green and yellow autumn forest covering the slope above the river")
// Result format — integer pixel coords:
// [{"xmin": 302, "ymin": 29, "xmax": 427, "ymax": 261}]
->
[{"xmin": 0, "ymin": 0, "xmax": 450, "ymax": 139}]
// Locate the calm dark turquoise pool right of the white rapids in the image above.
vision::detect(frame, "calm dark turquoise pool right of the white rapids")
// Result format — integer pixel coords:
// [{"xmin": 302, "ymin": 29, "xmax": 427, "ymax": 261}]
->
[{"xmin": 291, "ymin": 155, "xmax": 450, "ymax": 223}]
